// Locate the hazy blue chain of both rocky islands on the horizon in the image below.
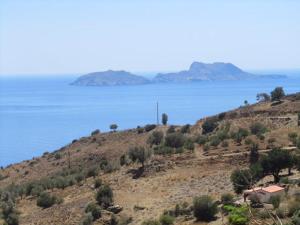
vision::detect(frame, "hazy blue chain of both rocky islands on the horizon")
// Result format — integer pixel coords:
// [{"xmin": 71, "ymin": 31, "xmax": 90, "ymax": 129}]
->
[{"xmin": 72, "ymin": 62, "xmax": 286, "ymax": 86}]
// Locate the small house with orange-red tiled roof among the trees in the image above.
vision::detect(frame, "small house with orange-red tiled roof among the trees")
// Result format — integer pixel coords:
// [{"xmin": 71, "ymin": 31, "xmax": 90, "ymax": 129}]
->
[{"xmin": 244, "ymin": 185, "xmax": 285, "ymax": 203}]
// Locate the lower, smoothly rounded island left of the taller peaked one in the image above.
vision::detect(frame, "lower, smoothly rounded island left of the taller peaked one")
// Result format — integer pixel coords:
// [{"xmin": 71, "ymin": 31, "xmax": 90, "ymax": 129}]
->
[{"xmin": 71, "ymin": 70, "xmax": 149, "ymax": 86}]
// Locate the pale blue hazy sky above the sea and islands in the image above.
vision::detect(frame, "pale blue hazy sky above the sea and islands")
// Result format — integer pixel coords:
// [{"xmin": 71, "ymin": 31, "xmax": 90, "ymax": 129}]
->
[{"xmin": 0, "ymin": 0, "xmax": 300, "ymax": 74}]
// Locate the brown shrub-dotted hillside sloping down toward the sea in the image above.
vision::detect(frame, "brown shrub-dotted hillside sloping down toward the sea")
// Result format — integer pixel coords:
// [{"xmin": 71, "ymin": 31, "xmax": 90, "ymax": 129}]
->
[{"xmin": 0, "ymin": 90, "xmax": 300, "ymax": 225}]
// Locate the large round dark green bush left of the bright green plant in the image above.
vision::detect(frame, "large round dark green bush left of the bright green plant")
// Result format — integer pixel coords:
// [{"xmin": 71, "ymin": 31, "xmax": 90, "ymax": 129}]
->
[{"xmin": 193, "ymin": 195, "xmax": 218, "ymax": 221}]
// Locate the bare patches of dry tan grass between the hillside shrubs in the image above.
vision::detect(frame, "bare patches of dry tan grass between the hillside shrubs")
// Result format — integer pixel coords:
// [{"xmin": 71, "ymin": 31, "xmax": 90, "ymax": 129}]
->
[{"xmin": 0, "ymin": 94, "xmax": 300, "ymax": 225}]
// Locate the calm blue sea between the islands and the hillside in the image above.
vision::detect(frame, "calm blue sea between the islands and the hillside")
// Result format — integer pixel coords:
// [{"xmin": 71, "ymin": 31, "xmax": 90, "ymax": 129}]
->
[{"xmin": 0, "ymin": 76, "xmax": 300, "ymax": 166}]
